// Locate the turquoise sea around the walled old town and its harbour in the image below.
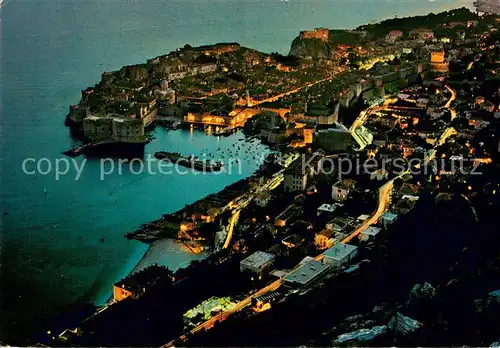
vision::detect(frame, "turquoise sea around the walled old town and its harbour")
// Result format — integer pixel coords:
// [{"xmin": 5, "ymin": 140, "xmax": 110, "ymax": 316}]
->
[{"xmin": 0, "ymin": 0, "xmax": 470, "ymax": 339}]
